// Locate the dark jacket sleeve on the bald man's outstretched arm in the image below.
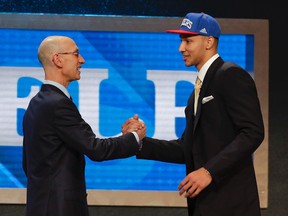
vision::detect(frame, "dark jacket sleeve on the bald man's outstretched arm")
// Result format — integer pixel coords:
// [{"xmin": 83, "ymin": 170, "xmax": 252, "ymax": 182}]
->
[{"xmin": 54, "ymin": 99, "xmax": 138, "ymax": 161}]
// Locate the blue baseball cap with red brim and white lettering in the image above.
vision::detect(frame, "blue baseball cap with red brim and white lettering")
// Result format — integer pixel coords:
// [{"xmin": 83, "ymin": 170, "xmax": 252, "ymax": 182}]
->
[{"xmin": 166, "ymin": 13, "xmax": 221, "ymax": 38}]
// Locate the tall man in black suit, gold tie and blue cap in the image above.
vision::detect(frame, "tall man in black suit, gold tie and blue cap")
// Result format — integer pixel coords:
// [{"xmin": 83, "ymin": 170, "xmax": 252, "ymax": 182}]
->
[{"xmin": 122, "ymin": 13, "xmax": 264, "ymax": 216}]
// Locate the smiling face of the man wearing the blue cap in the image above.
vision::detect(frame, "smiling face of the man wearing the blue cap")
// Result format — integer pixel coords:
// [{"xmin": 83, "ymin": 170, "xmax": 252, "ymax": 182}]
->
[{"xmin": 179, "ymin": 34, "xmax": 217, "ymax": 71}]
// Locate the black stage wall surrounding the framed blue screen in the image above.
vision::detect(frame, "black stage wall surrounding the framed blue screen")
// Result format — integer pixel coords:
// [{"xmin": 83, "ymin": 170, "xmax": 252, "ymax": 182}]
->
[{"xmin": 0, "ymin": 0, "xmax": 288, "ymax": 216}]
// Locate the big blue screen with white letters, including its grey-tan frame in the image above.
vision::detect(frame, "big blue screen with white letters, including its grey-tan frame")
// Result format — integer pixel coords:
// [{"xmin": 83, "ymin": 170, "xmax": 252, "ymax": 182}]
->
[{"xmin": 0, "ymin": 14, "xmax": 268, "ymax": 208}]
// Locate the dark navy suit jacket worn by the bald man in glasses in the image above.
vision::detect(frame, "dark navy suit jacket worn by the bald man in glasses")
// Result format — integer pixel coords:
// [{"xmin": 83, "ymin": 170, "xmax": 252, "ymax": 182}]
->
[{"xmin": 23, "ymin": 84, "xmax": 138, "ymax": 216}]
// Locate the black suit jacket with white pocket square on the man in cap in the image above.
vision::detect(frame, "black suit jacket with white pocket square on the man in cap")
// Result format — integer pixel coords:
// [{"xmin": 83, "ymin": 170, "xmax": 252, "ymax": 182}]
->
[{"xmin": 137, "ymin": 57, "xmax": 264, "ymax": 216}]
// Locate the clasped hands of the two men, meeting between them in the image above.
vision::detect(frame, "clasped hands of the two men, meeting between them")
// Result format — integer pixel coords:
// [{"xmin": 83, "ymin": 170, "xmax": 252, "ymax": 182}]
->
[{"xmin": 122, "ymin": 114, "xmax": 146, "ymax": 140}]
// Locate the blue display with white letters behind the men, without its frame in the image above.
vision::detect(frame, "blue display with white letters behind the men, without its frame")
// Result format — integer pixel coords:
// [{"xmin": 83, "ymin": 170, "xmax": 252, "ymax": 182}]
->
[{"xmin": 0, "ymin": 29, "xmax": 254, "ymax": 191}]
